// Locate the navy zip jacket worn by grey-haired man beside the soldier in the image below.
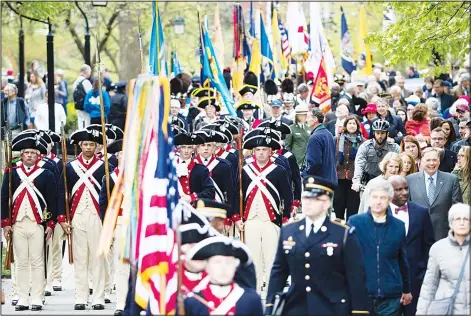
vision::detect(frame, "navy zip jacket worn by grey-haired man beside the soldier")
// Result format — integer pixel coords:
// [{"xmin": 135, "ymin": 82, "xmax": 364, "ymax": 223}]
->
[{"xmin": 348, "ymin": 208, "xmax": 411, "ymax": 298}]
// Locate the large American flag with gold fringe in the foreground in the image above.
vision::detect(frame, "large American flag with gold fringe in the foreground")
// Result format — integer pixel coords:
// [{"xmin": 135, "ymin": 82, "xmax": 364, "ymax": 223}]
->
[{"xmin": 136, "ymin": 78, "xmax": 179, "ymax": 315}]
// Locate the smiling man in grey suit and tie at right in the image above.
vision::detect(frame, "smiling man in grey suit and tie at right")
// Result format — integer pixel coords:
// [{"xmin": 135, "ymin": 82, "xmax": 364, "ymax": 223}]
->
[{"xmin": 406, "ymin": 148, "xmax": 463, "ymax": 241}]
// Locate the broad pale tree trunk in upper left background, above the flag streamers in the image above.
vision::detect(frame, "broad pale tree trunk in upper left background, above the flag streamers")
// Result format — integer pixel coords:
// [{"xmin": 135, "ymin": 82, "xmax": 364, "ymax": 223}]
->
[{"xmin": 118, "ymin": 6, "xmax": 140, "ymax": 81}]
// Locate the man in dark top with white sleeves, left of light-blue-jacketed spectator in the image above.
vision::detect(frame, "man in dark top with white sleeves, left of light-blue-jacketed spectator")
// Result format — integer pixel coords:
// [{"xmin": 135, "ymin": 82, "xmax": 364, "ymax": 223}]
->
[{"xmin": 73, "ymin": 64, "xmax": 93, "ymax": 129}]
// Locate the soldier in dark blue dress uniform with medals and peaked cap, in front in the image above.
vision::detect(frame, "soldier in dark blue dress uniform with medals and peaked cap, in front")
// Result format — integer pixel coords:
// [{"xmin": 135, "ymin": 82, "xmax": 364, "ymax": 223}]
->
[{"xmin": 265, "ymin": 176, "xmax": 368, "ymax": 316}]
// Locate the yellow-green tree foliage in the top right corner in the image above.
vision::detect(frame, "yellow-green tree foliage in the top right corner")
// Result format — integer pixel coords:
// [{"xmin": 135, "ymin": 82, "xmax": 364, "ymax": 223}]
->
[{"xmin": 366, "ymin": 1, "xmax": 470, "ymax": 73}]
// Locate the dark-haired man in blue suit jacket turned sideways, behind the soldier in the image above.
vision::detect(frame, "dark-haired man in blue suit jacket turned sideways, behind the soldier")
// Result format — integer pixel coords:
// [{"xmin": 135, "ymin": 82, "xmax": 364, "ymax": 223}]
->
[{"xmin": 304, "ymin": 108, "xmax": 338, "ymax": 185}]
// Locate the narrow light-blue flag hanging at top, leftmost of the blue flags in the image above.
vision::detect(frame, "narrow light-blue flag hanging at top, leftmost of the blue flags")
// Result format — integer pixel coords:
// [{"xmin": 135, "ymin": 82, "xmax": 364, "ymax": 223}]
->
[{"xmin": 149, "ymin": 1, "xmax": 168, "ymax": 76}]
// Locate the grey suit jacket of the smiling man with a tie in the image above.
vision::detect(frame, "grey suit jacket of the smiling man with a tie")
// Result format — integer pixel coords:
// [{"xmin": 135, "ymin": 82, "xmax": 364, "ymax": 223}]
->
[{"xmin": 406, "ymin": 171, "xmax": 463, "ymax": 240}]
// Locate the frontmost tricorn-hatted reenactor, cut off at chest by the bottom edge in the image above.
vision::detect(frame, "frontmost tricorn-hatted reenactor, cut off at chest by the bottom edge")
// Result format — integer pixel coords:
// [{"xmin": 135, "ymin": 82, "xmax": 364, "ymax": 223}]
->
[{"xmin": 185, "ymin": 236, "xmax": 263, "ymax": 315}]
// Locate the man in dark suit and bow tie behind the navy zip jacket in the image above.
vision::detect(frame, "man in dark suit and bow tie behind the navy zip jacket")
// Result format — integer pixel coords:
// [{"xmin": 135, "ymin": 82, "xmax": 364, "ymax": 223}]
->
[{"xmin": 388, "ymin": 176, "xmax": 435, "ymax": 316}]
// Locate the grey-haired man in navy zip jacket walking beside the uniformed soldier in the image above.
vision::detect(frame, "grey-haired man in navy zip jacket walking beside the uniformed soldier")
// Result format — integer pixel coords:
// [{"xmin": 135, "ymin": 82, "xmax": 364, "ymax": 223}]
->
[{"xmin": 349, "ymin": 179, "xmax": 412, "ymax": 315}]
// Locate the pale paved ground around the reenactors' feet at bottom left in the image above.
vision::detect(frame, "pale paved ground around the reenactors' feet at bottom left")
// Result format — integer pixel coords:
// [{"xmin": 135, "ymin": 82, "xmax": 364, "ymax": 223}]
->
[{"xmin": 0, "ymin": 251, "xmax": 116, "ymax": 316}]
